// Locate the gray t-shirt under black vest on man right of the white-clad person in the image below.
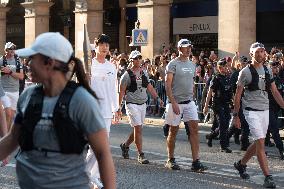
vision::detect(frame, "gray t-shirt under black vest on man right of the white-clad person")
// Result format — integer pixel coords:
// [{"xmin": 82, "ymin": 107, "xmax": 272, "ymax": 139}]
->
[{"xmin": 121, "ymin": 70, "xmax": 150, "ymax": 104}]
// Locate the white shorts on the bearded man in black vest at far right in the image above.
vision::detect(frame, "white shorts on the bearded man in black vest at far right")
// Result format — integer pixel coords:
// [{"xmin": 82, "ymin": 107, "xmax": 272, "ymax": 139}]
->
[{"xmin": 243, "ymin": 110, "xmax": 269, "ymax": 140}]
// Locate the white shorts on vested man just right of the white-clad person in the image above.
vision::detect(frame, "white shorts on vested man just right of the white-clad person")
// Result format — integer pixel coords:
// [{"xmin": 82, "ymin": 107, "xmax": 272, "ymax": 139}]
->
[{"xmin": 125, "ymin": 103, "xmax": 146, "ymax": 127}]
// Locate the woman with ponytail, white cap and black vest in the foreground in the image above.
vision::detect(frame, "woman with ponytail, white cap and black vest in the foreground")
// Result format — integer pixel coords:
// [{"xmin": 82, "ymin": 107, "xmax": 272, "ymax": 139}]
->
[{"xmin": 0, "ymin": 32, "xmax": 116, "ymax": 189}]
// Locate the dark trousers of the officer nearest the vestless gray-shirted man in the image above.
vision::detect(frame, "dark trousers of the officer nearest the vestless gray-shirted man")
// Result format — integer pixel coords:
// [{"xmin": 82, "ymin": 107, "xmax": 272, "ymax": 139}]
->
[{"xmin": 216, "ymin": 106, "xmax": 231, "ymax": 148}]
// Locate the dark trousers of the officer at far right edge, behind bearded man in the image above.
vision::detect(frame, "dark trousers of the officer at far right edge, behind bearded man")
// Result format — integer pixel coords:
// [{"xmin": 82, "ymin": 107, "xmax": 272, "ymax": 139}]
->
[{"xmin": 267, "ymin": 109, "xmax": 283, "ymax": 152}]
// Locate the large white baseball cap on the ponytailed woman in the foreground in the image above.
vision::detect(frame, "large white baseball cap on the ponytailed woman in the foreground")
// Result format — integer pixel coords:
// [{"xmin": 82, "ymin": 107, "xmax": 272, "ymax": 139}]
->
[{"xmin": 16, "ymin": 32, "xmax": 73, "ymax": 63}]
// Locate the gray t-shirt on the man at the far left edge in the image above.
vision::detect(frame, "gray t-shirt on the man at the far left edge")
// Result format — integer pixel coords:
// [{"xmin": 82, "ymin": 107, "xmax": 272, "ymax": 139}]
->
[{"xmin": 0, "ymin": 57, "xmax": 23, "ymax": 92}]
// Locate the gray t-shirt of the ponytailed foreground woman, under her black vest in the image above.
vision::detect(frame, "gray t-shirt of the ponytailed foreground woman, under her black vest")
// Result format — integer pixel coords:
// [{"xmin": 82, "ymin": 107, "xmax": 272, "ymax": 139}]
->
[{"xmin": 16, "ymin": 86, "xmax": 105, "ymax": 189}]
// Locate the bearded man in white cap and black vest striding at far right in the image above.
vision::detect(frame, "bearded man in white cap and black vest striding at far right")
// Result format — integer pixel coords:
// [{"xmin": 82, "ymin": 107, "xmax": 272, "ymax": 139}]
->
[{"xmin": 233, "ymin": 42, "xmax": 284, "ymax": 188}]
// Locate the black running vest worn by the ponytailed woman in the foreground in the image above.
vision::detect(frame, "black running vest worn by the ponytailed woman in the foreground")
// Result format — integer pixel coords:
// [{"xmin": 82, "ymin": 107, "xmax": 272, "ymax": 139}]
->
[{"xmin": 18, "ymin": 81, "xmax": 87, "ymax": 154}]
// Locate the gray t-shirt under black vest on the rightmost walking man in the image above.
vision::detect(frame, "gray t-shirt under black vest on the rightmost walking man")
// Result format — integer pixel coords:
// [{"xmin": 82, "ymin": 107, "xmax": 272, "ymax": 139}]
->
[{"xmin": 237, "ymin": 66, "xmax": 273, "ymax": 110}]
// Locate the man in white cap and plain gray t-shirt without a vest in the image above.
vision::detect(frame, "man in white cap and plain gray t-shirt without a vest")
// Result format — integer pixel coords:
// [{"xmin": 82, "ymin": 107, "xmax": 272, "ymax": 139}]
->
[{"xmin": 165, "ymin": 39, "xmax": 207, "ymax": 172}]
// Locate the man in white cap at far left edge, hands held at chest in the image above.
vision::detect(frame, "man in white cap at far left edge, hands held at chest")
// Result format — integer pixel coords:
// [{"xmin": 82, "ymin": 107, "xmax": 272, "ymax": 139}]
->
[{"xmin": 0, "ymin": 42, "xmax": 24, "ymax": 131}]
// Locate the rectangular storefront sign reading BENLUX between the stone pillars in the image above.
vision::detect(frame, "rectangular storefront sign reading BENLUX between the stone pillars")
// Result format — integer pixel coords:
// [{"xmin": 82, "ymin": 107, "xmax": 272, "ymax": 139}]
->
[{"xmin": 173, "ymin": 16, "xmax": 218, "ymax": 35}]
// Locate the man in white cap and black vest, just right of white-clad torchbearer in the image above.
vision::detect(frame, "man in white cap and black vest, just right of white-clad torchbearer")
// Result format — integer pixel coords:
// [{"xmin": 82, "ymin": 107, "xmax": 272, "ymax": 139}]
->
[{"xmin": 119, "ymin": 50, "xmax": 163, "ymax": 164}]
